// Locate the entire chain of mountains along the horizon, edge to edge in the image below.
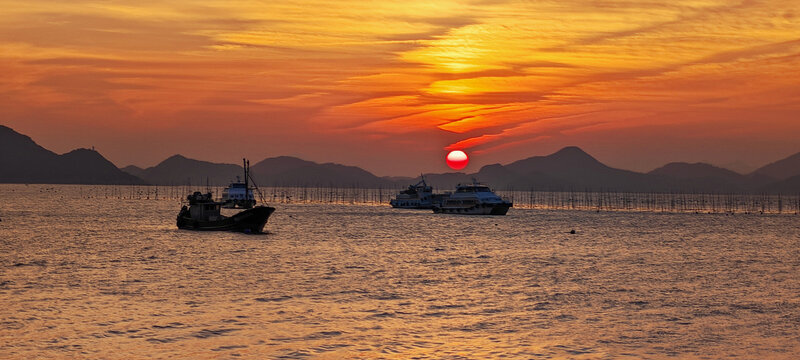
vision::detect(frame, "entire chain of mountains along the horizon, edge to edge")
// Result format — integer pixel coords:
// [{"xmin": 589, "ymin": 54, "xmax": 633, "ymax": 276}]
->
[{"xmin": 0, "ymin": 125, "xmax": 800, "ymax": 194}]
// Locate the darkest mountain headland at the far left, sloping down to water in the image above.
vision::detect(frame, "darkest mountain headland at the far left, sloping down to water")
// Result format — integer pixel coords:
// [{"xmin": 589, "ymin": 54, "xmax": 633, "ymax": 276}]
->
[{"xmin": 0, "ymin": 125, "xmax": 144, "ymax": 184}]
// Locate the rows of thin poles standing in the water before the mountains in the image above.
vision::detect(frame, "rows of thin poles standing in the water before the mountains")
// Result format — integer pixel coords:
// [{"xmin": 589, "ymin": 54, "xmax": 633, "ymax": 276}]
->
[{"xmin": 42, "ymin": 185, "xmax": 800, "ymax": 214}]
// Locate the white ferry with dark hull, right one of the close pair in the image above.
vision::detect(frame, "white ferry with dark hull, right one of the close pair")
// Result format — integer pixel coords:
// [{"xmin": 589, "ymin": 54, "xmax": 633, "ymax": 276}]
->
[{"xmin": 433, "ymin": 180, "xmax": 514, "ymax": 215}]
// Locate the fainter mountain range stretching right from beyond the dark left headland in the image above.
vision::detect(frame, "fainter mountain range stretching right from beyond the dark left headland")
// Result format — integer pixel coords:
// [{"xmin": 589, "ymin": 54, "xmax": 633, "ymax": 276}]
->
[{"xmin": 125, "ymin": 146, "xmax": 792, "ymax": 192}]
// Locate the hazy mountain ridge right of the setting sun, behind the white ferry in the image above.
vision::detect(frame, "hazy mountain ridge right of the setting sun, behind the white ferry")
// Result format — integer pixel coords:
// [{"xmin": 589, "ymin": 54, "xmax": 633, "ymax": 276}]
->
[{"xmin": 416, "ymin": 146, "xmax": 800, "ymax": 193}]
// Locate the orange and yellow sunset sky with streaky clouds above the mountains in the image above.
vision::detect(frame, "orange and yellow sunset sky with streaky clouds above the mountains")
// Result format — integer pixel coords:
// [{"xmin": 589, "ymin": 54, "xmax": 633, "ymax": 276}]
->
[{"xmin": 0, "ymin": 0, "xmax": 800, "ymax": 175}]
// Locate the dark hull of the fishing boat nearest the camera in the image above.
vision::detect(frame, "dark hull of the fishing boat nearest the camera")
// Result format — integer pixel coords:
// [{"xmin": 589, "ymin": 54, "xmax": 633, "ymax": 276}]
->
[{"xmin": 177, "ymin": 206, "xmax": 275, "ymax": 234}]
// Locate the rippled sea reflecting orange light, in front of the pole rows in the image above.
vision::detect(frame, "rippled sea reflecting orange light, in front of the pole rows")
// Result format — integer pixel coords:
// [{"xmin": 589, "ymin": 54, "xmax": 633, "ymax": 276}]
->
[{"xmin": 0, "ymin": 185, "xmax": 800, "ymax": 359}]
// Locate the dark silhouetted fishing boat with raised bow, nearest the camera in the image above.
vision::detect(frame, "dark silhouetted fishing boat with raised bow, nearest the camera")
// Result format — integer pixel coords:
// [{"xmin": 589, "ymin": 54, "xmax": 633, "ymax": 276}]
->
[{"xmin": 177, "ymin": 191, "xmax": 275, "ymax": 234}]
